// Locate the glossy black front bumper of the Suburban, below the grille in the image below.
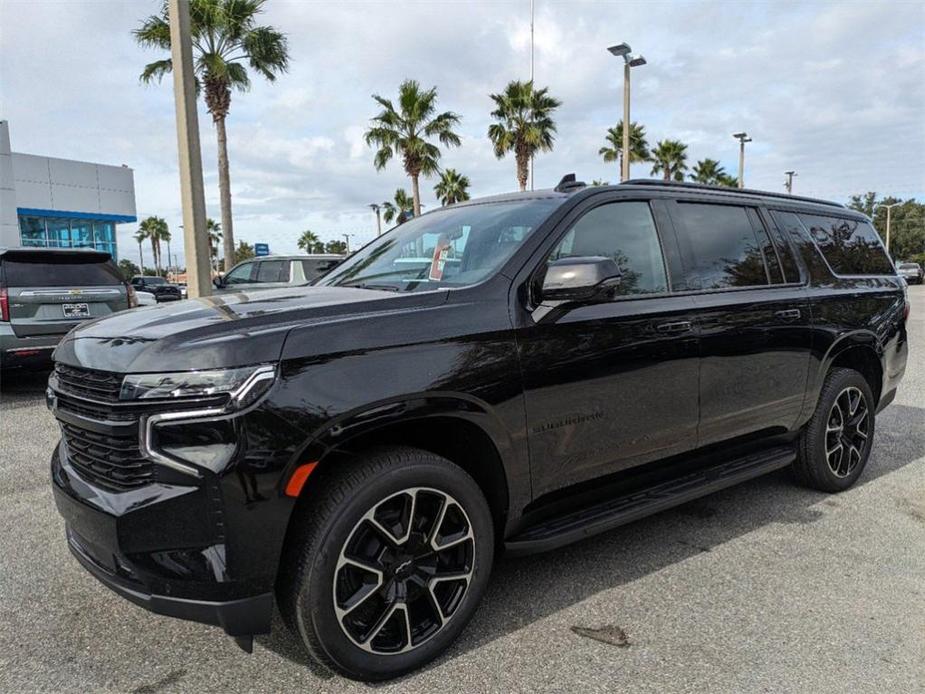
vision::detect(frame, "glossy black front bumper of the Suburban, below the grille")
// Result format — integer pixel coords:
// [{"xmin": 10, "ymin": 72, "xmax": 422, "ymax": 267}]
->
[{"xmin": 51, "ymin": 444, "xmax": 273, "ymax": 637}]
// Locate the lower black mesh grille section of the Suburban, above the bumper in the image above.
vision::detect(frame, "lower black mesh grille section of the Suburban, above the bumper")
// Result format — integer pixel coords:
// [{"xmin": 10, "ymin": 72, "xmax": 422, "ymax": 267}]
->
[{"xmin": 61, "ymin": 422, "xmax": 154, "ymax": 491}]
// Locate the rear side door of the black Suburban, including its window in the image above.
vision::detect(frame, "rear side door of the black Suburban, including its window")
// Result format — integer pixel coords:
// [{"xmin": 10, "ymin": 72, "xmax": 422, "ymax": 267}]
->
[{"xmin": 668, "ymin": 200, "xmax": 812, "ymax": 446}]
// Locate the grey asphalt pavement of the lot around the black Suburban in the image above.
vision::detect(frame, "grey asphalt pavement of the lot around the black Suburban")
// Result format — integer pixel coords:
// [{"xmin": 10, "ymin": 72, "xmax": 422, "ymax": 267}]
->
[{"xmin": 0, "ymin": 287, "xmax": 925, "ymax": 694}]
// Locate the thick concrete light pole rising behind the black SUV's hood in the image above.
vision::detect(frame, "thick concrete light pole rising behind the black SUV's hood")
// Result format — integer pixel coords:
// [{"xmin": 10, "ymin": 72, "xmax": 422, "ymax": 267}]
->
[{"xmin": 167, "ymin": 0, "xmax": 212, "ymax": 299}]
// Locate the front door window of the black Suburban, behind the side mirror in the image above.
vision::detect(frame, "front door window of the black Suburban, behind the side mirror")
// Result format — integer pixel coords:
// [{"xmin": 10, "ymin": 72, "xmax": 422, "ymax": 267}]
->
[{"xmin": 549, "ymin": 202, "xmax": 668, "ymax": 294}]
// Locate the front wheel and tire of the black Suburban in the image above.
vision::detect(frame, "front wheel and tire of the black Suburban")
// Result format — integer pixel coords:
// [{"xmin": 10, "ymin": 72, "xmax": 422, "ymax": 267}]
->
[{"xmin": 278, "ymin": 447, "xmax": 494, "ymax": 681}]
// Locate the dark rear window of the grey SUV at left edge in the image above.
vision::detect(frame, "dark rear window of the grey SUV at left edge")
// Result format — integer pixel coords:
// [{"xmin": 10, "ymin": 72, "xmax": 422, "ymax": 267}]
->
[{"xmin": 2, "ymin": 253, "xmax": 122, "ymax": 287}]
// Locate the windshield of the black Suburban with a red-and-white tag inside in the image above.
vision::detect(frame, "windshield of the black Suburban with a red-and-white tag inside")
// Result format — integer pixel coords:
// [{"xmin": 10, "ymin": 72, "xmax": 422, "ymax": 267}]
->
[{"xmin": 318, "ymin": 198, "xmax": 559, "ymax": 292}]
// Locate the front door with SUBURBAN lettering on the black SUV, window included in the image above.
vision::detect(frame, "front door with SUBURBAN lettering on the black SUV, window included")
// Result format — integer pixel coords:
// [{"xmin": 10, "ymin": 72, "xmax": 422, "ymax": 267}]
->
[{"xmin": 516, "ymin": 198, "xmax": 698, "ymax": 497}]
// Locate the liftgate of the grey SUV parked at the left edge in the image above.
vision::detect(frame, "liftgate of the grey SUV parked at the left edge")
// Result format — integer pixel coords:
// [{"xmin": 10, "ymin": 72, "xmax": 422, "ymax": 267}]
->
[{"xmin": 0, "ymin": 250, "xmax": 128, "ymax": 337}]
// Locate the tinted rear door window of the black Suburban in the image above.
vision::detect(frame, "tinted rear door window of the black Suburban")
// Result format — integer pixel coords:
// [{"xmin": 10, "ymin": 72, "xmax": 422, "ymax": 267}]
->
[{"xmin": 678, "ymin": 202, "xmax": 771, "ymax": 289}]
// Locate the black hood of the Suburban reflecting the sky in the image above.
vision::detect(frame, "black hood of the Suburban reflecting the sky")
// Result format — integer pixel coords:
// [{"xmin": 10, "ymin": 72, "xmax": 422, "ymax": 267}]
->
[{"xmin": 54, "ymin": 287, "xmax": 447, "ymax": 373}]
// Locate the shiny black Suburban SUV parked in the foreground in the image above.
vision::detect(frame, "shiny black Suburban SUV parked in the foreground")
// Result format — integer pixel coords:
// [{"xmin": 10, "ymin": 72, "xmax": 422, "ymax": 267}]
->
[{"xmin": 48, "ymin": 181, "xmax": 909, "ymax": 680}]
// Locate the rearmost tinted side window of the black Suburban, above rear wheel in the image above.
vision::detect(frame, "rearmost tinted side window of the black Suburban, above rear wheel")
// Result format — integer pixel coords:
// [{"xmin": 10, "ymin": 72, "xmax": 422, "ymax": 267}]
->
[{"xmin": 798, "ymin": 214, "xmax": 893, "ymax": 275}]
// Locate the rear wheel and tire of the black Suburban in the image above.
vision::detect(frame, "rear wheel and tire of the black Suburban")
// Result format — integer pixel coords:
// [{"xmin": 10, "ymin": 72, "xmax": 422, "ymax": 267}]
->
[{"xmin": 793, "ymin": 368, "xmax": 876, "ymax": 493}]
